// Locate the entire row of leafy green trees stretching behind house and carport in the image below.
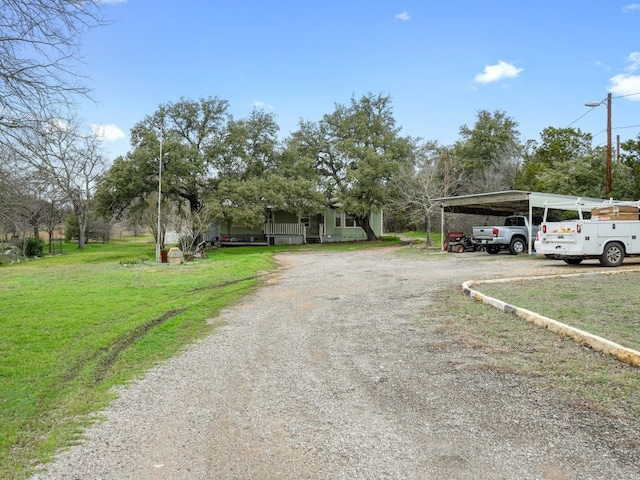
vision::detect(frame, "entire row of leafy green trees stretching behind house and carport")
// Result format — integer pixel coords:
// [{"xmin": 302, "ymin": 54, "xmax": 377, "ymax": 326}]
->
[{"xmin": 91, "ymin": 93, "xmax": 640, "ymax": 244}]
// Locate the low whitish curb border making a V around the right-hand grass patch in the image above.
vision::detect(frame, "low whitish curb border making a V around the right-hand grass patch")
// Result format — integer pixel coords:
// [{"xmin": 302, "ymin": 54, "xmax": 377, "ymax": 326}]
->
[{"xmin": 462, "ymin": 269, "xmax": 640, "ymax": 368}]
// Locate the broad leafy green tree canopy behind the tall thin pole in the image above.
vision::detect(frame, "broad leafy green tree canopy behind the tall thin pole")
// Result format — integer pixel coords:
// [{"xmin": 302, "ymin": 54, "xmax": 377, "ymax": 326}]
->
[{"xmin": 97, "ymin": 97, "xmax": 319, "ymax": 246}]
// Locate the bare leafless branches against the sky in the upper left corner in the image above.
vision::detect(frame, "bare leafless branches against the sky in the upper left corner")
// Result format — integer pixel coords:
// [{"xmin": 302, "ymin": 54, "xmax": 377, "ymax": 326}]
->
[{"xmin": 0, "ymin": 0, "xmax": 105, "ymax": 138}]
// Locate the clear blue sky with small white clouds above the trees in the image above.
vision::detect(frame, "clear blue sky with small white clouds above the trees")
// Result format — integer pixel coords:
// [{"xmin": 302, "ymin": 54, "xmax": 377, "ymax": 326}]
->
[{"xmin": 84, "ymin": 0, "xmax": 640, "ymax": 158}]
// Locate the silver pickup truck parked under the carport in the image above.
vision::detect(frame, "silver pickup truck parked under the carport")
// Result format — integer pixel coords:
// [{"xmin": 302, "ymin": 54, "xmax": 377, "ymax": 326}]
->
[{"xmin": 471, "ymin": 215, "xmax": 542, "ymax": 255}]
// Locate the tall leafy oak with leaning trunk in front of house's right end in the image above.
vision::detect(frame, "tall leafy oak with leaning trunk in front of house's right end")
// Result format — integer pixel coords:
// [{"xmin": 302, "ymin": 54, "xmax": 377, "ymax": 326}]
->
[{"xmin": 293, "ymin": 93, "xmax": 413, "ymax": 239}]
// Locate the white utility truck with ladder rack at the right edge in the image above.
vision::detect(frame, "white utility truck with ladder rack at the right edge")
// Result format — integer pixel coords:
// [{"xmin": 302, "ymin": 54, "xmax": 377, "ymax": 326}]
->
[{"xmin": 534, "ymin": 200, "xmax": 640, "ymax": 267}]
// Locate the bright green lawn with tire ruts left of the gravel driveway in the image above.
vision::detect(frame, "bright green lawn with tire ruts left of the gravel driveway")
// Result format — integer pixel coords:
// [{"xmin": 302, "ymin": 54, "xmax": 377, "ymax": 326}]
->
[{"xmin": 0, "ymin": 236, "xmax": 399, "ymax": 479}]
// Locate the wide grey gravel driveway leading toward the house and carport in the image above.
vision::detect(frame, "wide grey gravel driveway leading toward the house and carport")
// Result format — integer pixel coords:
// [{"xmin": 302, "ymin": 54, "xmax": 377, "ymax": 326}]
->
[{"xmin": 34, "ymin": 248, "xmax": 640, "ymax": 480}]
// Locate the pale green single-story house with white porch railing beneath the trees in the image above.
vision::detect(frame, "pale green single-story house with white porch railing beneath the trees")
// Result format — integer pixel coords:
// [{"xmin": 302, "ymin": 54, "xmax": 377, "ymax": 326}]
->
[{"xmin": 204, "ymin": 207, "xmax": 383, "ymax": 246}]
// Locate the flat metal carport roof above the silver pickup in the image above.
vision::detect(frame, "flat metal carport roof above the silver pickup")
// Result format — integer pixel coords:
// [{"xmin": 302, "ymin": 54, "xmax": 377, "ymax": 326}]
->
[{"xmin": 435, "ymin": 190, "xmax": 604, "ymax": 216}]
